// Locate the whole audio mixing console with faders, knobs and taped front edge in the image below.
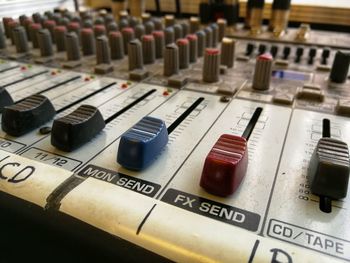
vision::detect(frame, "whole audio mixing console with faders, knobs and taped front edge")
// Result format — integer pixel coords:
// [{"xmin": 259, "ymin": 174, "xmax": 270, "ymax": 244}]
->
[{"xmin": 0, "ymin": 5, "xmax": 350, "ymax": 262}]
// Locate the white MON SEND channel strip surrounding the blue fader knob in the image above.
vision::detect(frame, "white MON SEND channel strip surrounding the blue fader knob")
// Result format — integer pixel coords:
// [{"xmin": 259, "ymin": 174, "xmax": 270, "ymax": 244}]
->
[{"xmin": 66, "ymin": 91, "xmax": 227, "ymax": 202}]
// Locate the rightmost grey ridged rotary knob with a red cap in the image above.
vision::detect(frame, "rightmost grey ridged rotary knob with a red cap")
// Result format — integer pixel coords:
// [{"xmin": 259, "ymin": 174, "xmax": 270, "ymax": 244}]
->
[{"xmin": 253, "ymin": 53, "xmax": 273, "ymax": 90}]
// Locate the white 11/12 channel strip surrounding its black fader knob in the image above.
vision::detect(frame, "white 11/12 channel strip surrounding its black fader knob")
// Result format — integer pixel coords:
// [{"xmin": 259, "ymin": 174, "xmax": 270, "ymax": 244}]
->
[{"xmin": 18, "ymin": 84, "xmax": 175, "ymax": 170}]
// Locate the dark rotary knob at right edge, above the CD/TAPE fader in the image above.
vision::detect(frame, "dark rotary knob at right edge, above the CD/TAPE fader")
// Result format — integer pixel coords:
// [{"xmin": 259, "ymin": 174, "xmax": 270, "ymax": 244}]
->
[{"xmin": 329, "ymin": 51, "xmax": 350, "ymax": 83}]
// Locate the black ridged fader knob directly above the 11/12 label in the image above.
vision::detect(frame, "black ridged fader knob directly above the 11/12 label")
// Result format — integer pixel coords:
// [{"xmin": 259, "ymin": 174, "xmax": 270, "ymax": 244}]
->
[{"xmin": 51, "ymin": 105, "xmax": 105, "ymax": 152}]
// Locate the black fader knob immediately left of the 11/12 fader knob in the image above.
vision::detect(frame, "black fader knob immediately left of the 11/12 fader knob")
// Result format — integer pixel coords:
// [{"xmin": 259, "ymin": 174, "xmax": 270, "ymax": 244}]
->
[{"xmin": 1, "ymin": 95, "xmax": 56, "ymax": 136}]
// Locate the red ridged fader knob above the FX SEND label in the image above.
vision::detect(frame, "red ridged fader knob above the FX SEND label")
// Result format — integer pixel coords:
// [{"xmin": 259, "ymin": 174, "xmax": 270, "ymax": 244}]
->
[{"xmin": 200, "ymin": 134, "xmax": 248, "ymax": 196}]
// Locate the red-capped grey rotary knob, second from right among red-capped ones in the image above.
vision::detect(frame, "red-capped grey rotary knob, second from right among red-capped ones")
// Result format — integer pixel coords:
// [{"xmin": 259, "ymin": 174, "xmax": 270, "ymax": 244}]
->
[{"xmin": 202, "ymin": 48, "xmax": 220, "ymax": 83}]
